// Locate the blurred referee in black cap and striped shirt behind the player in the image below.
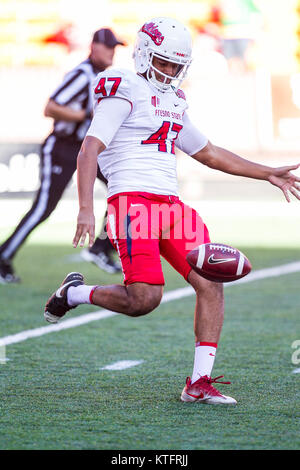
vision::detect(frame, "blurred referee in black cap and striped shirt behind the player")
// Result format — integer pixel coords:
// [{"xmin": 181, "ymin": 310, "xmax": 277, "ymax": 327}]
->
[{"xmin": 0, "ymin": 28, "xmax": 125, "ymax": 284}]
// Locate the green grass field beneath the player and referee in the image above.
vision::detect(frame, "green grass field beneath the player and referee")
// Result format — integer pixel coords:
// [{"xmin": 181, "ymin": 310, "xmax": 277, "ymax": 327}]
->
[{"xmin": 0, "ymin": 204, "xmax": 300, "ymax": 450}]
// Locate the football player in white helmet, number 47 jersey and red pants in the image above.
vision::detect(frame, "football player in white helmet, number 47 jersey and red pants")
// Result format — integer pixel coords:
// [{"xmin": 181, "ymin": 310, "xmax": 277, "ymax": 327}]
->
[{"xmin": 44, "ymin": 18, "xmax": 300, "ymax": 405}]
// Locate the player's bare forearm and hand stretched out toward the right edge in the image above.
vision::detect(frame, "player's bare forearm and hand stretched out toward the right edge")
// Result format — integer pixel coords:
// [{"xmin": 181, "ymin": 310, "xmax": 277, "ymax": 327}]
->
[{"xmin": 192, "ymin": 142, "xmax": 300, "ymax": 202}]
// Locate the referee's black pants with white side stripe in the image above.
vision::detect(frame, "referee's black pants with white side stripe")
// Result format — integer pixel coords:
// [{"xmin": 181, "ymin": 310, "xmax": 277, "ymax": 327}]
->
[{"xmin": 0, "ymin": 134, "xmax": 112, "ymax": 259}]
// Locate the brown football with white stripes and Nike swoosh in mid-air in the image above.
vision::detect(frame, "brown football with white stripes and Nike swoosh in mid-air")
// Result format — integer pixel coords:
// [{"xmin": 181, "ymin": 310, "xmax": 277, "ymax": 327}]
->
[{"xmin": 186, "ymin": 243, "xmax": 252, "ymax": 282}]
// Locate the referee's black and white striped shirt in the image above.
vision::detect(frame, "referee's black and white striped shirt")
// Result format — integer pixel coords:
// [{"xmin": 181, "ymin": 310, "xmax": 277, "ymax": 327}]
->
[{"xmin": 50, "ymin": 58, "xmax": 102, "ymax": 141}]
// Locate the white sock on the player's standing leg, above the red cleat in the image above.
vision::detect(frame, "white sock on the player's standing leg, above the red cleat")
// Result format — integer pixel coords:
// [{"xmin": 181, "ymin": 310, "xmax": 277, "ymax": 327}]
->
[{"xmin": 192, "ymin": 341, "xmax": 218, "ymax": 383}]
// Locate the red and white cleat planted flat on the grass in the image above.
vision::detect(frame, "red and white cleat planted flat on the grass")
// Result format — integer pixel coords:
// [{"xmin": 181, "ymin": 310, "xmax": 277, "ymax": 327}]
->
[{"xmin": 181, "ymin": 375, "xmax": 237, "ymax": 405}]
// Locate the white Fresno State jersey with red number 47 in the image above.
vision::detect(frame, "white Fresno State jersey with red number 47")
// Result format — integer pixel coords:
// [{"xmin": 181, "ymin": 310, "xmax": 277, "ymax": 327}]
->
[{"xmin": 87, "ymin": 69, "xmax": 207, "ymax": 197}]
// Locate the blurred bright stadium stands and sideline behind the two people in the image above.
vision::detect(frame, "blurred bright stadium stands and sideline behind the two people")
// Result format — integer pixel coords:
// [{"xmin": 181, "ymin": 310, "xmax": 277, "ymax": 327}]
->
[{"xmin": 0, "ymin": 0, "xmax": 300, "ymax": 246}]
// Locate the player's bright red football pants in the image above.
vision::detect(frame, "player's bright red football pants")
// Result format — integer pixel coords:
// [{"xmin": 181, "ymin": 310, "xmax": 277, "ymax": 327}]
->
[{"xmin": 107, "ymin": 192, "xmax": 210, "ymax": 285}]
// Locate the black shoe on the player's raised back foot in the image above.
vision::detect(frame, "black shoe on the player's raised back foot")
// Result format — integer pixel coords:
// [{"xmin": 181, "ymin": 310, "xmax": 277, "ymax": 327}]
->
[{"xmin": 44, "ymin": 273, "xmax": 84, "ymax": 323}]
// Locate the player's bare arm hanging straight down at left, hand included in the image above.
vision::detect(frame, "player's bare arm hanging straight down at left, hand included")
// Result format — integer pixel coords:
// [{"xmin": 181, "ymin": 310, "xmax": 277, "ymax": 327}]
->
[{"xmin": 73, "ymin": 136, "xmax": 105, "ymax": 248}]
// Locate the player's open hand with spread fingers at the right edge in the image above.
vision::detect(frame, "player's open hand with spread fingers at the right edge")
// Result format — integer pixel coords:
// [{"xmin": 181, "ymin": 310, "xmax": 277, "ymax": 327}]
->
[{"xmin": 268, "ymin": 164, "xmax": 300, "ymax": 202}]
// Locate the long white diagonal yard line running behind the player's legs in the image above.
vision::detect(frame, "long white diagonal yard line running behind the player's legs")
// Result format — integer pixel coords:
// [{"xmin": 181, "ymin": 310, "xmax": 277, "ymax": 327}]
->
[{"xmin": 0, "ymin": 261, "xmax": 300, "ymax": 347}]
